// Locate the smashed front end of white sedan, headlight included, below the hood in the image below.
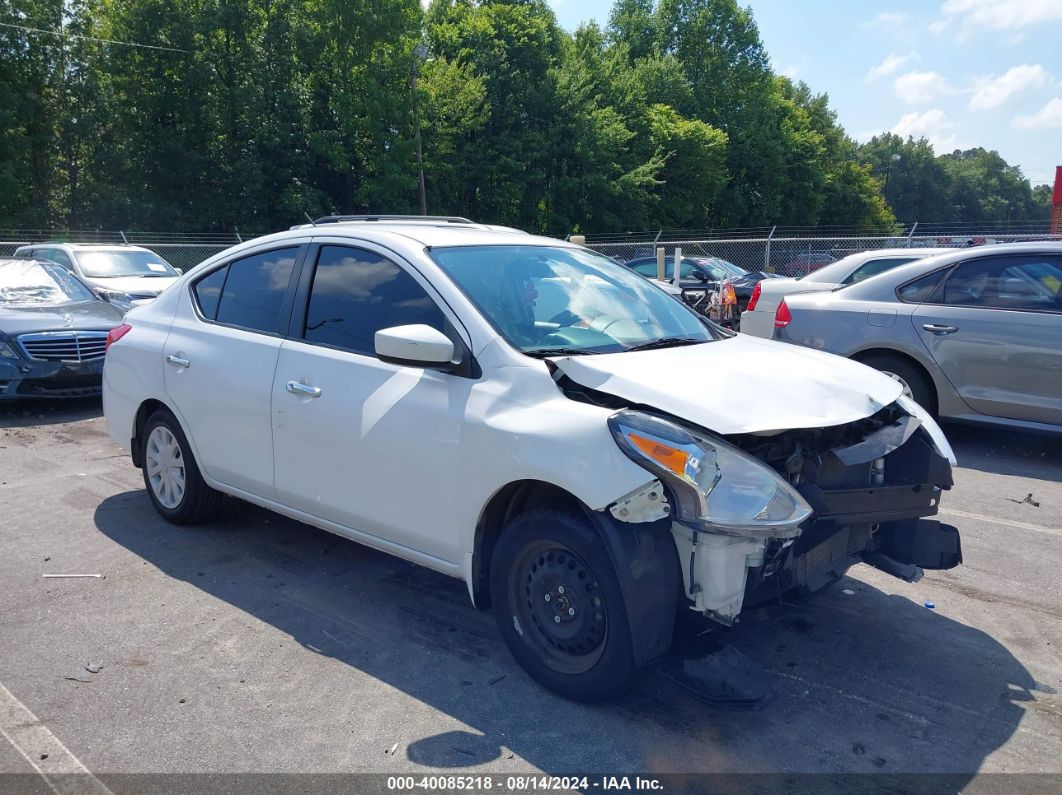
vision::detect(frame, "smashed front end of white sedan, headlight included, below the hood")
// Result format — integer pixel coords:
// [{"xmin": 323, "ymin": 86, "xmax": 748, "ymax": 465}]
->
[{"xmin": 611, "ymin": 397, "xmax": 962, "ymax": 624}]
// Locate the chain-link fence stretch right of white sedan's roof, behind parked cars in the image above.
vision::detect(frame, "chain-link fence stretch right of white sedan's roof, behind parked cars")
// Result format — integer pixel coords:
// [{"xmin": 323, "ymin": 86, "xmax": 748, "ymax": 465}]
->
[{"xmin": 586, "ymin": 225, "xmax": 1062, "ymax": 276}]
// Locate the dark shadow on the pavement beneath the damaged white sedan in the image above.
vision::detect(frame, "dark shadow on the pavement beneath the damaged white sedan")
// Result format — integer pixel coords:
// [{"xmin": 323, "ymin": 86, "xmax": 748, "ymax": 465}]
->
[{"xmin": 95, "ymin": 491, "xmax": 1037, "ymax": 775}]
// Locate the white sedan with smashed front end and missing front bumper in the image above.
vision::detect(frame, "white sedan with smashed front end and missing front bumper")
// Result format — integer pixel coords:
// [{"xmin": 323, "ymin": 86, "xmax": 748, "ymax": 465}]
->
[{"xmin": 104, "ymin": 218, "xmax": 961, "ymax": 699}]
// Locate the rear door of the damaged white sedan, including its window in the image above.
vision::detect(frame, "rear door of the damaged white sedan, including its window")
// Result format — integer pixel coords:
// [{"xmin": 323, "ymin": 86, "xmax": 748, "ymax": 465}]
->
[{"xmin": 162, "ymin": 241, "xmax": 304, "ymax": 499}]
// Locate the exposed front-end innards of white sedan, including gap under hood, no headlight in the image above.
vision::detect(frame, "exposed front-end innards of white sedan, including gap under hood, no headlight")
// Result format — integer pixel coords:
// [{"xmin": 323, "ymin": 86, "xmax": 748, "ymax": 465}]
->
[{"xmin": 554, "ymin": 374, "xmax": 962, "ymax": 624}]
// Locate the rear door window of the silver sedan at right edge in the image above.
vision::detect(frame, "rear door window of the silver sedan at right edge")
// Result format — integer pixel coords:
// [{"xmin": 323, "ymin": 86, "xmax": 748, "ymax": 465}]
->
[{"xmin": 943, "ymin": 255, "xmax": 1062, "ymax": 311}]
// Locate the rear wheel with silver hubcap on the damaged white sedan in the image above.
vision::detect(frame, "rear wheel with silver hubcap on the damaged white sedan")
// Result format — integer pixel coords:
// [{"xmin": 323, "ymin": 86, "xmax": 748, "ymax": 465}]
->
[{"xmin": 140, "ymin": 409, "xmax": 221, "ymax": 524}]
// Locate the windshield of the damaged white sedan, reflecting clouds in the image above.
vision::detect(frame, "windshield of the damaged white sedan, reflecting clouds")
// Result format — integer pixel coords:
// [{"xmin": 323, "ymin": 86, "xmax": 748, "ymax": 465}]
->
[{"xmin": 431, "ymin": 245, "xmax": 718, "ymax": 356}]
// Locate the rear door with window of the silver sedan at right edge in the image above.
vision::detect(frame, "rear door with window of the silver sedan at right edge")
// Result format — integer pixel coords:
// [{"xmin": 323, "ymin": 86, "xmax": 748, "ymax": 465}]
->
[{"xmin": 912, "ymin": 254, "xmax": 1062, "ymax": 425}]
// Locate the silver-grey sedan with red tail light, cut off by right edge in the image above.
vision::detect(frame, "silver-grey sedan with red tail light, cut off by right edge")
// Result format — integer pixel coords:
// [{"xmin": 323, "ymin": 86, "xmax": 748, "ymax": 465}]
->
[{"xmin": 774, "ymin": 243, "xmax": 1062, "ymax": 432}]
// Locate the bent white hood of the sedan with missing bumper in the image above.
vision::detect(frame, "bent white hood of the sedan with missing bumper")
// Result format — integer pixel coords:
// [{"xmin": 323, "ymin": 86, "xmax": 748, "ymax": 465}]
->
[{"xmin": 552, "ymin": 334, "xmax": 903, "ymax": 434}]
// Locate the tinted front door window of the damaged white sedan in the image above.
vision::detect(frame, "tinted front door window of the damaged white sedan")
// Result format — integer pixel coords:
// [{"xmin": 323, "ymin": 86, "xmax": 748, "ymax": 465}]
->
[{"xmin": 303, "ymin": 245, "xmax": 446, "ymax": 356}]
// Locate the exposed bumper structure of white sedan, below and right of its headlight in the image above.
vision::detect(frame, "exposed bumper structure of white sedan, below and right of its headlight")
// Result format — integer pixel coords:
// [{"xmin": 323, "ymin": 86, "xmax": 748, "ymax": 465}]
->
[{"xmin": 671, "ymin": 411, "xmax": 962, "ymax": 624}]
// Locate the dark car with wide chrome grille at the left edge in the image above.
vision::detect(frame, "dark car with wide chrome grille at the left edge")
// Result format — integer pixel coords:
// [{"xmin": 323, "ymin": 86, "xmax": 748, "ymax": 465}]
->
[{"xmin": 0, "ymin": 259, "xmax": 122, "ymax": 400}]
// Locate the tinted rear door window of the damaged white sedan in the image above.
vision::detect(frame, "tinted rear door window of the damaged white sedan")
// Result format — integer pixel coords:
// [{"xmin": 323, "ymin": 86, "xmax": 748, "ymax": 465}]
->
[{"xmin": 217, "ymin": 248, "xmax": 298, "ymax": 333}]
